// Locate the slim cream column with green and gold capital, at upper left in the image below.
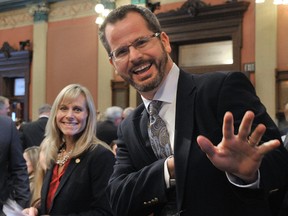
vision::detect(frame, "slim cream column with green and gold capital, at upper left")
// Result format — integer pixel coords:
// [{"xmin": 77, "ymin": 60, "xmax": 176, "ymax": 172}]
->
[{"xmin": 29, "ymin": 3, "xmax": 49, "ymax": 120}]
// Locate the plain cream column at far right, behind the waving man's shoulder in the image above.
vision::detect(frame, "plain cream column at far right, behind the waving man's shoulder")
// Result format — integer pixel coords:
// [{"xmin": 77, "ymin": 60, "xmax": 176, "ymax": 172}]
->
[{"xmin": 255, "ymin": 1, "xmax": 277, "ymax": 121}]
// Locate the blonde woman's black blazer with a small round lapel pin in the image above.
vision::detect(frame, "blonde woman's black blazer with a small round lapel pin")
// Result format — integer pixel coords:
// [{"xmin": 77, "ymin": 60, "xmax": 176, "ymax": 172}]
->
[{"xmin": 40, "ymin": 145, "xmax": 115, "ymax": 216}]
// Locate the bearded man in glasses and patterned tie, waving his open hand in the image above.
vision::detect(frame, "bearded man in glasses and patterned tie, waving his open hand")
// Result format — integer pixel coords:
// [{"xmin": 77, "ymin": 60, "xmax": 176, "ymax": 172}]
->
[{"xmin": 100, "ymin": 5, "xmax": 288, "ymax": 216}]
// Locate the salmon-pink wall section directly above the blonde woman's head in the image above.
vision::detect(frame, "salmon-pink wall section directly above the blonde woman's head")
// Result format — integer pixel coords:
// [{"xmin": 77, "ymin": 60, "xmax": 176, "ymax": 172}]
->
[{"xmin": 46, "ymin": 16, "xmax": 98, "ymax": 105}]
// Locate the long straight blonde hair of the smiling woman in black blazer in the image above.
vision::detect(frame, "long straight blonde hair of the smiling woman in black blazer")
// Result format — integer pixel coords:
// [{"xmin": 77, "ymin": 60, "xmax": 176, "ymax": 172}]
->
[{"xmin": 45, "ymin": 84, "xmax": 105, "ymax": 167}]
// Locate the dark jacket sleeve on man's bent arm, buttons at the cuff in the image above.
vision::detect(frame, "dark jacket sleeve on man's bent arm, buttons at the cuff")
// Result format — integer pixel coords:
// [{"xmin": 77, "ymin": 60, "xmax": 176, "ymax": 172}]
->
[{"xmin": 107, "ymin": 121, "xmax": 167, "ymax": 216}]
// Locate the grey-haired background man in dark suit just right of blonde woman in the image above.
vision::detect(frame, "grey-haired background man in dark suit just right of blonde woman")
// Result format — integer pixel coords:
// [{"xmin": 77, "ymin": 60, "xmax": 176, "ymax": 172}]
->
[{"xmin": 96, "ymin": 106, "xmax": 123, "ymax": 145}]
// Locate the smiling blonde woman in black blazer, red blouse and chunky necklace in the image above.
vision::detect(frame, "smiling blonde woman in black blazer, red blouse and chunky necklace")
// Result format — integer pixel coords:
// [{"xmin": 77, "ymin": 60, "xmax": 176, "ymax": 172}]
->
[{"xmin": 23, "ymin": 84, "xmax": 115, "ymax": 216}]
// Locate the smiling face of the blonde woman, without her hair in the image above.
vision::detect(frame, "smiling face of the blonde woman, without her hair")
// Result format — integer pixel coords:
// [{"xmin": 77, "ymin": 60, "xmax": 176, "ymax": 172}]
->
[{"xmin": 56, "ymin": 94, "xmax": 88, "ymax": 138}]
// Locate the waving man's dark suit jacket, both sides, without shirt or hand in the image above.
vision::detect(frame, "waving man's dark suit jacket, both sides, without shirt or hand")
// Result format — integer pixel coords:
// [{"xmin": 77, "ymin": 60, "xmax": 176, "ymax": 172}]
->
[{"xmin": 107, "ymin": 71, "xmax": 288, "ymax": 216}]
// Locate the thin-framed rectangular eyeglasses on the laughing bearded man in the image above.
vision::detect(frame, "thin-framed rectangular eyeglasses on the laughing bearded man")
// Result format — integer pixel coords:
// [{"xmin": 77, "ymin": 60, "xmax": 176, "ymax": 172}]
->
[{"xmin": 109, "ymin": 32, "xmax": 160, "ymax": 62}]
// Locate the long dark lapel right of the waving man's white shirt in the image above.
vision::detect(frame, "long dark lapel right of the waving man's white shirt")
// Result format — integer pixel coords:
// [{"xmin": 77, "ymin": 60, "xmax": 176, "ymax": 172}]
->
[{"xmin": 174, "ymin": 71, "xmax": 196, "ymax": 209}]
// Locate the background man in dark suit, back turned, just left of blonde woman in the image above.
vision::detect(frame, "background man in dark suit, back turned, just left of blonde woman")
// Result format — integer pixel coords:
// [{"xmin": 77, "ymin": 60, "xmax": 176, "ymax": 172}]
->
[{"xmin": 19, "ymin": 104, "xmax": 51, "ymax": 150}]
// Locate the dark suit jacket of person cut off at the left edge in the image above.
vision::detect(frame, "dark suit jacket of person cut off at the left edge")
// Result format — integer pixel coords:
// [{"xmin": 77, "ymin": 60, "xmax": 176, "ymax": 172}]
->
[{"xmin": 0, "ymin": 116, "xmax": 30, "ymax": 216}]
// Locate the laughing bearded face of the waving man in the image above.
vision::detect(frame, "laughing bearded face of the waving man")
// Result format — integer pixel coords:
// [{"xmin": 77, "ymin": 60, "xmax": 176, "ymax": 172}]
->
[{"xmin": 105, "ymin": 12, "xmax": 172, "ymax": 98}]
